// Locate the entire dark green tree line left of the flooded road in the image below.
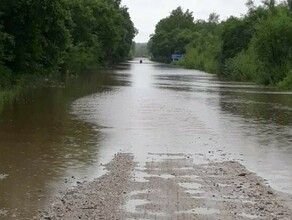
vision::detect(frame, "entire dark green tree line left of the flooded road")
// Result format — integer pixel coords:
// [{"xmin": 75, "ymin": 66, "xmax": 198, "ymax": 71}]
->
[{"xmin": 0, "ymin": 0, "xmax": 137, "ymax": 89}]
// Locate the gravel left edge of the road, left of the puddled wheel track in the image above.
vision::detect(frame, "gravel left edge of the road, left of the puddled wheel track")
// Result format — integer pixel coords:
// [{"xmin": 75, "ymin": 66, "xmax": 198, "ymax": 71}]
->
[{"xmin": 39, "ymin": 154, "xmax": 134, "ymax": 220}]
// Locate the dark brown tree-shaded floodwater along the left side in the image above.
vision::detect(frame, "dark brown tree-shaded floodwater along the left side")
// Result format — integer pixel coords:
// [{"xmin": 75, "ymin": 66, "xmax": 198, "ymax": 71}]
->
[{"xmin": 0, "ymin": 69, "xmax": 118, "ymax": 219}]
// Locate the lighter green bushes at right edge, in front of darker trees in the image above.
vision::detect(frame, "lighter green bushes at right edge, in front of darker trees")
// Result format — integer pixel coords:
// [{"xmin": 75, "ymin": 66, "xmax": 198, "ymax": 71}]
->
[{"xmin": 224, "ymin": 8, "xmax": 292, "ymax": 88}]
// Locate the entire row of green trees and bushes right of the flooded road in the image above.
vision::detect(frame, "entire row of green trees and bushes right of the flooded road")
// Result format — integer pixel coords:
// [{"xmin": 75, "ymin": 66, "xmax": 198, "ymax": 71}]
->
[{"xmin": 148, "ymin": 0, "xmax": 292, "ymax": 89}]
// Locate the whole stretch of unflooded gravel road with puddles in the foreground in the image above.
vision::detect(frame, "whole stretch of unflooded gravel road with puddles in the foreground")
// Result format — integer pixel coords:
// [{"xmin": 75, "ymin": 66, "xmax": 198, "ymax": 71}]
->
[{"xmin": 39, "ymin": 154, "xmax": 292, "ymax": 220}]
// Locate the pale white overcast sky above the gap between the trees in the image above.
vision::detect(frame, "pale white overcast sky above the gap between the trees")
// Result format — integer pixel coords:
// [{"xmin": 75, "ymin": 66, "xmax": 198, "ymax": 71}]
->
[{"xmin": 122, "ymin": 0, "xmax": 261, "ymax": 42}]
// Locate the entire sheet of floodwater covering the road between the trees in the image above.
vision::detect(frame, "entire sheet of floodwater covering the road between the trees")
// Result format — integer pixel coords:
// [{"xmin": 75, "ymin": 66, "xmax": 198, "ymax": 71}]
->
[{"xmin": 0, "ymin": 60, "xmax": 292, "ymax": 219}]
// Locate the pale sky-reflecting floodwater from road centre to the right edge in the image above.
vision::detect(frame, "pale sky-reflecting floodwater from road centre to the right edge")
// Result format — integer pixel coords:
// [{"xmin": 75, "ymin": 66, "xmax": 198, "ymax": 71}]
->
[{"xmin": 73, "ymin": 59, "xmax": 292, "ymax": 195}]
